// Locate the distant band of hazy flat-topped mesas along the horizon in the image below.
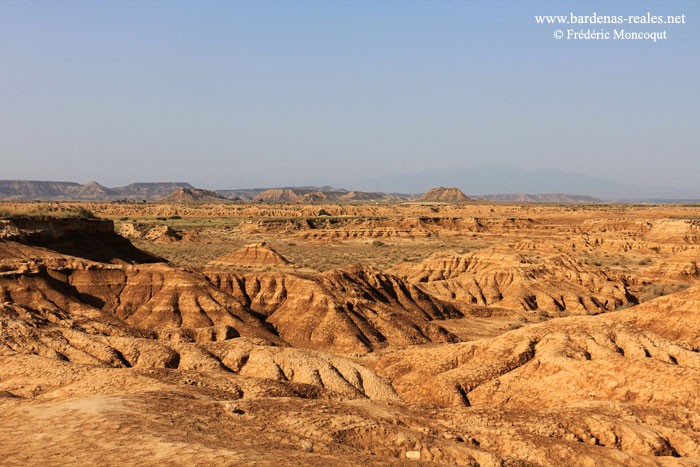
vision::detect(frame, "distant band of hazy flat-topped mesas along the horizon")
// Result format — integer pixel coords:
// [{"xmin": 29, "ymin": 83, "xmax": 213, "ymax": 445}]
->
[{"xmin": 0, "ymin": 180, "xmax": 700, "ymax": 204}]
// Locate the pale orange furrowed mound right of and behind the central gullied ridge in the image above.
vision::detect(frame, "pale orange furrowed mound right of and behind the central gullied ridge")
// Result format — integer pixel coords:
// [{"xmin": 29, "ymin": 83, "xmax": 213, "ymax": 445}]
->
[{"xmin": 390, "ymin": 245, "xmax": 636, "ymax": 314}]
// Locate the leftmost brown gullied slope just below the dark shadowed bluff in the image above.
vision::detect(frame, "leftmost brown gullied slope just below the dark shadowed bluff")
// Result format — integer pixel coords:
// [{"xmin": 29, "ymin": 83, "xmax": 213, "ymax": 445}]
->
[{"xmin": 0, "ymin": 263, "xmax": 281, "ymax": 343}]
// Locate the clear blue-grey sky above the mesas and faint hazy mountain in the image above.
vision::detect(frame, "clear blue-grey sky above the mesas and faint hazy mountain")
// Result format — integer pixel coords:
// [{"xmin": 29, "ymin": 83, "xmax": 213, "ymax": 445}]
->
[{"xmin": 0, "ymin": 0, "xmax": 700, "ymax": 191}]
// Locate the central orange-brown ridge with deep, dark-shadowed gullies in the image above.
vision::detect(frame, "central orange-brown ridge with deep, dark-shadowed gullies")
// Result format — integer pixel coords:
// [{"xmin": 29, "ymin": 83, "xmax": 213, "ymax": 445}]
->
[{"xmin": 206, "ymin": 266, "xmax": 461, "ymax": 352}]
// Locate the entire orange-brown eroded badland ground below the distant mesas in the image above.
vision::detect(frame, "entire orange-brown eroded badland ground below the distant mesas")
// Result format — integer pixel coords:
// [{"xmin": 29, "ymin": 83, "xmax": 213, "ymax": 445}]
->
[{"xmin": 0, "ymin": 202, "xmax": 700, "ymax": 466}]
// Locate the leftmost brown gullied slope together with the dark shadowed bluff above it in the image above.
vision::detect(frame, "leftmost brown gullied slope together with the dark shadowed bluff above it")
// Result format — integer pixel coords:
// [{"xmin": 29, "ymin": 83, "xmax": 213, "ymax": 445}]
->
[{"xmin": 0, "ymin": 218, "xmax": 281, "ymax": 343}]
